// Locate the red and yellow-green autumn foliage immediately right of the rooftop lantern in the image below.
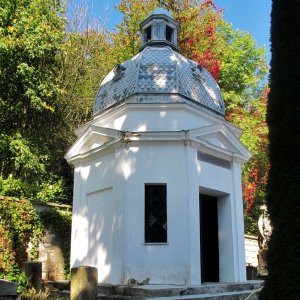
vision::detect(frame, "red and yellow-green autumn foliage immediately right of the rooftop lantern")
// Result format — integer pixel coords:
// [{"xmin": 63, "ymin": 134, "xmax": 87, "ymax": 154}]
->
[{"xmin": 166, "ymin": 0, "xmax": 225, "ymax": 80}]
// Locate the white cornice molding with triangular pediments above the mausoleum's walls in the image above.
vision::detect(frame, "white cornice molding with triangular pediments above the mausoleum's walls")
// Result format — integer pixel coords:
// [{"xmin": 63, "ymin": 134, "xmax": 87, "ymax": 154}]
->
[{"xmin": 65, "ymin": 124, "xmax": 251, "ymax": 165}]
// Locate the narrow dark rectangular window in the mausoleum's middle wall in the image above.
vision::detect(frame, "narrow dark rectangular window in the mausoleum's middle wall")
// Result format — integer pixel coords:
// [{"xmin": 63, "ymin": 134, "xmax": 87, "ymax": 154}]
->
[{"xmin": 145, "ymin": 184, "xmax": 167, "ymax": 243}]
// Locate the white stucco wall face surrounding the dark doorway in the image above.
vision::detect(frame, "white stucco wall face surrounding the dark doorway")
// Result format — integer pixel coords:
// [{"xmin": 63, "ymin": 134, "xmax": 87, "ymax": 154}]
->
[{"xmin": 188, "ymin": 148, "xmax": 246, "ymax": 283}]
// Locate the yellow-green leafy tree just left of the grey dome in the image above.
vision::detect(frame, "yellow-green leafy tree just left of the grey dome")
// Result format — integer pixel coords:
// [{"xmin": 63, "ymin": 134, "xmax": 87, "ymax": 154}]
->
[{"xmin": 58, "ymin": 28, "xmax": 116, "ymax": 131}]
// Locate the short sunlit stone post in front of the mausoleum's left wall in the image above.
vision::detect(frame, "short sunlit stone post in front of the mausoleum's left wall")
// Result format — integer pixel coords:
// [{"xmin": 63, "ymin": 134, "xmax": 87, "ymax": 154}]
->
[{"xmin": 70, "ymin": 266, "xmax": 98, "ymax": 300}]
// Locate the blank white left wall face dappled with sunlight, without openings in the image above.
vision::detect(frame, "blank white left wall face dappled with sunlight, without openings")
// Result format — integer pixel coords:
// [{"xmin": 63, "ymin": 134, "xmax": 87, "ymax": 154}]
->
[{"xmin": 71, "ymin": 153, "xmax": 124, "ymax": 283}]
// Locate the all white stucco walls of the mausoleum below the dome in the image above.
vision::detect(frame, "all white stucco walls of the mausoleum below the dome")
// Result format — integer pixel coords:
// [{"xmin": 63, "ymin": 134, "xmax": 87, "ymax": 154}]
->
[{"xmin": 68, "ymin": 104, "xmax": 250, "ymax": 286}]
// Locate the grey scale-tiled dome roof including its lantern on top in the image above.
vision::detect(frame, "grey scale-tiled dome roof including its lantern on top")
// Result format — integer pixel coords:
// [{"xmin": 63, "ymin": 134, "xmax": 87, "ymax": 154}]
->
[{"xmin": 94, "ymin": 6, "xmax": 224, "ymax": 115}]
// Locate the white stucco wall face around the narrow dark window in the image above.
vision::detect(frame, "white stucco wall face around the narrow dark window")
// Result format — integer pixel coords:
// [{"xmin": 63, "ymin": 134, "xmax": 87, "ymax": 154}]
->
[{"xmin": 125, "ymin": 144, "xmax": 188, "ymax": 284}]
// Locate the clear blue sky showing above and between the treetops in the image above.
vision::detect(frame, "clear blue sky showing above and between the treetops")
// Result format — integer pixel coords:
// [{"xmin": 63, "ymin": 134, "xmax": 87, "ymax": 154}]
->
[{"xmin": 80, "ymin": 0, "xmax": 271, "ymax": 61}]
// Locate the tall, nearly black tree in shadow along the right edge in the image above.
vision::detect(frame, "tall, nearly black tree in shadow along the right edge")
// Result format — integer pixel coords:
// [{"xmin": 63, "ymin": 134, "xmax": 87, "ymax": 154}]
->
[{"xmin": 261, "ymin": 0, "xmax": 300, "ymax": 299}]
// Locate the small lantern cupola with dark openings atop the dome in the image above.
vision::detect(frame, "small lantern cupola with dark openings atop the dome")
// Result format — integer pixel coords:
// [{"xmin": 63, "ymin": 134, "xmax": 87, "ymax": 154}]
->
[{"xmin": 141, "ymin": 7, "xmax": 179, "ymax": 51}]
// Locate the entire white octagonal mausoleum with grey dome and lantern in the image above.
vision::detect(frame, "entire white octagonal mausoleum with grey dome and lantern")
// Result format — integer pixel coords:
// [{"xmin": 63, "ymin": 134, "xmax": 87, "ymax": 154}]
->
[{"xmin": 66, "ymin": 8, "xmax": 250, "ymax": 286}]
